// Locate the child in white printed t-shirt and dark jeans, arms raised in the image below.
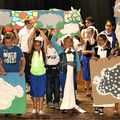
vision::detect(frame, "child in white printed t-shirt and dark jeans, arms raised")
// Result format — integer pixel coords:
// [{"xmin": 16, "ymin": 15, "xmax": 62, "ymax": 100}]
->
[{"xmin": 46, "ymin": 43, "xmax": 60, "ymax": 109}]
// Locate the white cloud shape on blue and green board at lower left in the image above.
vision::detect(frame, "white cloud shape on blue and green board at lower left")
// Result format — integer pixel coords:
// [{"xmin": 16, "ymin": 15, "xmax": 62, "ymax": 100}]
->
[{"xmin": 0, "ymin": 78, "xmax": 24, "ymax": 110}]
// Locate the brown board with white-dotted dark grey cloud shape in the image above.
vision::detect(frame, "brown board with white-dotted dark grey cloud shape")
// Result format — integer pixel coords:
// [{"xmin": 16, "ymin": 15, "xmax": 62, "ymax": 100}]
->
[{"xmin": 90, "ymin": 56, "xmax": 120, "ymax": 105}]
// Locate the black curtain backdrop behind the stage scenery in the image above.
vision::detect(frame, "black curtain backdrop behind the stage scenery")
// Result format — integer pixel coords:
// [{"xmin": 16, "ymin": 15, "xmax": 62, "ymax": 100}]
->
[{"xmin": 0, "ymin": 0, "xmax": 115, "ymax": 31}]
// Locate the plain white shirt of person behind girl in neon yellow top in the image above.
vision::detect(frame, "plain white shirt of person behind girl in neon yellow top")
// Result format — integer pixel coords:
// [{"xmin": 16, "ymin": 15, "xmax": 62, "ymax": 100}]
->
[{"xmin": 18, "ymin": 26, "xmax": 34, "ymax": 53}]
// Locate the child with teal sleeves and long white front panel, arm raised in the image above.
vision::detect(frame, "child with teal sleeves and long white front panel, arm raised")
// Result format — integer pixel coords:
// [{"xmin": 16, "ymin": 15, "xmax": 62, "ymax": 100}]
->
[{"xmin": 52, "ymin": 30, "xmax": 85, "ymax": 113}]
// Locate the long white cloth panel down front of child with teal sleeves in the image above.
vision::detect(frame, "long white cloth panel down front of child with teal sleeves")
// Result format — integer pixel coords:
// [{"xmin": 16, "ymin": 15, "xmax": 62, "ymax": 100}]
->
[{"xmin": 60, "ymin": 53, "xmax": 86, "ymax": 113}]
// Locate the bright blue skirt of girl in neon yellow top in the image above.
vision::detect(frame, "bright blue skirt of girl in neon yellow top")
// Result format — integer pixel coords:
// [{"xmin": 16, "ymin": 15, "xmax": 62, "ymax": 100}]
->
[{"xmin": 30, "ymin": 74, "xmax": 46, "ymax": 97}]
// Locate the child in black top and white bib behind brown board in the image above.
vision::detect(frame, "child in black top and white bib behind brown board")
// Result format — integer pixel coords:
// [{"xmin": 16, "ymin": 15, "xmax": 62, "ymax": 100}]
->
[{"xmin": 93, "ymin": 33, "xmax": 112, "ymax": 115}]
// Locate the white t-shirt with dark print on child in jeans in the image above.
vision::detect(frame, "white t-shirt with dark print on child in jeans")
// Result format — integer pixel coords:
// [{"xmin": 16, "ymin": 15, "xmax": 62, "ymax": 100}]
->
[{"xmin": 46, "ymin": 46, "xmax": 60, "ymax": 65}]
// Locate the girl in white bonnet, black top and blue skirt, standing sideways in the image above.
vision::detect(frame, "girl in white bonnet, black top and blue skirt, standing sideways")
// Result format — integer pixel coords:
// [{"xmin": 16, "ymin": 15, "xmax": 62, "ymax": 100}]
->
[{"xmin": 83, "ymin": 26, "xmax": 97, "ymax": 97}]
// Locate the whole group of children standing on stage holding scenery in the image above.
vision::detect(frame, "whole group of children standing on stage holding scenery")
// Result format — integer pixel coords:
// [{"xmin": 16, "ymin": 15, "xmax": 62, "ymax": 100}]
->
[{"xmin": 0, "ymin": 17, "xmax": 119, "ymax": 115}]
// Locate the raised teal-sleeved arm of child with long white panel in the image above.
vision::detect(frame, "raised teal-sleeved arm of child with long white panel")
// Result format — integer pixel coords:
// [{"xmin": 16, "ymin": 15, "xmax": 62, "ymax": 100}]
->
[{"xmin": 51, "ymin": 35, "xmax": 64, "ymax": 54}]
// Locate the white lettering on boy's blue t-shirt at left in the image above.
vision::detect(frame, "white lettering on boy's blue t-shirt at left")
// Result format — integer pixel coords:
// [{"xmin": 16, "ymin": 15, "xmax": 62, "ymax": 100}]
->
[{"xmin": 3, "ymin": 51, "xmax": 17, "ymax": 64}]
